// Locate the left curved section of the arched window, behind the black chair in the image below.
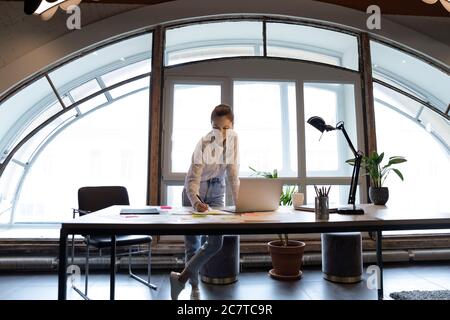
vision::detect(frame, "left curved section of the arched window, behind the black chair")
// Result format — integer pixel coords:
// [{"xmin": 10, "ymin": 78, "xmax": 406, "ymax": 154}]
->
[{"xmin": 0, "ymin": 33, "xmax": 152, "ymax": 223}]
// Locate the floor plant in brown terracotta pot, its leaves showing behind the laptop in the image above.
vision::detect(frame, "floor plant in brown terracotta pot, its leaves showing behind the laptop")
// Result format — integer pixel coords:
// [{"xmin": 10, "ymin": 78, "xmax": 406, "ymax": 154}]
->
[{"xmin": 249, "ymin": 167, "xmax": 305, "ymax": 280}]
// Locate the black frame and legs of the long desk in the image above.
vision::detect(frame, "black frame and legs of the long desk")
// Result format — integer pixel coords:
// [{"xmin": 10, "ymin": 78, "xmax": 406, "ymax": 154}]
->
[{"xmin": 58, "ymin": 220, "xmax": 450, "ymax": 300}]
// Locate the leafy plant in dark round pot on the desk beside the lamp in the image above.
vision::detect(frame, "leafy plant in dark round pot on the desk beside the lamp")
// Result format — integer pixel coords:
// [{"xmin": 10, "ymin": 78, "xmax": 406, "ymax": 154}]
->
[{"xmin": 346, "ymin": 151, "xmax": 407, "ymax": 205}]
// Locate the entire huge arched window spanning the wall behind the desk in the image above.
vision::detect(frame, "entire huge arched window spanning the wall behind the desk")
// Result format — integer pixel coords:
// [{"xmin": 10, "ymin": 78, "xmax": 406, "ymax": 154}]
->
[{"xmin": 0, "ymin": 17, "xmax": 450, "ymax": 229}]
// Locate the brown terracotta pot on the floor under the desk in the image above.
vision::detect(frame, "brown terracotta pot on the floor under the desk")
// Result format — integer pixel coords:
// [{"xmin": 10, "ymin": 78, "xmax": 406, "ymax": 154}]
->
[{"xmin": 267, "ymin": 240, "xmax": 305, "ymax": 280}]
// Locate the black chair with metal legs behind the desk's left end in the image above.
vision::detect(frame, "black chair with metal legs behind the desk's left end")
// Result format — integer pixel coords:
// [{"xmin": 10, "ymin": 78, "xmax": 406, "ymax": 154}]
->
[{"xmin": 72, "ymin": 186, "xmax": 157, "ymax": 300}]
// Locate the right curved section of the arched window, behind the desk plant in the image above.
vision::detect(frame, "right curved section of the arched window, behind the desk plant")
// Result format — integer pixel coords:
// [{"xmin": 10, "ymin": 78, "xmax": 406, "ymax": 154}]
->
[{"xmin": 371, "ymin": 41, "xmax": 450, "ymax": 214}]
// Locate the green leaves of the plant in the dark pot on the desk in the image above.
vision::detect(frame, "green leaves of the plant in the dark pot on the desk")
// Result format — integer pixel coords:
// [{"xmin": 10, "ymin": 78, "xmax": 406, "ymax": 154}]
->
[{"xmin": 346, "ymin": 151, "xmax": 407, "ymax": 188}]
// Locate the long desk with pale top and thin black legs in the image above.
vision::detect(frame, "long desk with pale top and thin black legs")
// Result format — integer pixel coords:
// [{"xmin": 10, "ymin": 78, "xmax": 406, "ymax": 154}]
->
[{"xmin": 58, "ymin": 205, "xmax": 450, "ymax": 300}]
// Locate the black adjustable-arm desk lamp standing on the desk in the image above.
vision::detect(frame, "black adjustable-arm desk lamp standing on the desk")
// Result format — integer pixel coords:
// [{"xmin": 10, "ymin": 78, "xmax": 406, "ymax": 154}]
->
[{"xmin": 307, "ymin": 116, "xmax": 364, "ymax": 214}]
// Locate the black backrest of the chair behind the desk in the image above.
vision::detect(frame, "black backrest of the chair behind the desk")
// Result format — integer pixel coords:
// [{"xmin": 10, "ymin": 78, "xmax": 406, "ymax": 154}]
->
[{"xmin": 78, "ymin": 186, "xmax": 130, "ymax": 215}]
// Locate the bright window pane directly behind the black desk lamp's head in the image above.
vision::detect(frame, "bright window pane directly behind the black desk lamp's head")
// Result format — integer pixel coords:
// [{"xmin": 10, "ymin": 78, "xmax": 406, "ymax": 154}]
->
[{"xmin": 304, "ymin": 83, "xmax": 358, "ymax": 177}]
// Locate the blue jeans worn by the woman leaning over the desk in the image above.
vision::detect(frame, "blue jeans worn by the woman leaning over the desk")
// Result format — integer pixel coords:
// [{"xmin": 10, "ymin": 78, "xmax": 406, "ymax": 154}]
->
[{"xmin": 185, "ymin": 177, "xmax": 225, "ymax": 286}]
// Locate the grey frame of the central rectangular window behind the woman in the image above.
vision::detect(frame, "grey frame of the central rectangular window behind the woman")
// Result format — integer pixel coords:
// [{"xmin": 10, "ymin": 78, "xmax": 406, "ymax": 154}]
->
[{"xmin": 160, "ymin": 57, "xmax": 367, "ymax": 210}]
